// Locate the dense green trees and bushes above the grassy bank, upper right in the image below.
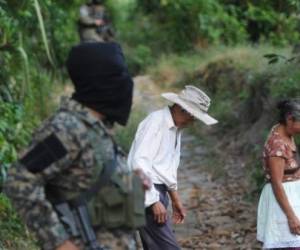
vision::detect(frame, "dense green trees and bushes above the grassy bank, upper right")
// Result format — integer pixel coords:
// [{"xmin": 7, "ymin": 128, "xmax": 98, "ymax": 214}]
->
[{"xmin": 108, "ymin": 0, "xmax": 299, "ymax": 72}]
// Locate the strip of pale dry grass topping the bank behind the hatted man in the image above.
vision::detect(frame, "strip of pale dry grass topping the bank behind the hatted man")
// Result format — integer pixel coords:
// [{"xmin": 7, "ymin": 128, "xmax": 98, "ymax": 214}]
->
[{"xmin": 145, "ymin": 44, "xmax": 291, "ymax": 87}]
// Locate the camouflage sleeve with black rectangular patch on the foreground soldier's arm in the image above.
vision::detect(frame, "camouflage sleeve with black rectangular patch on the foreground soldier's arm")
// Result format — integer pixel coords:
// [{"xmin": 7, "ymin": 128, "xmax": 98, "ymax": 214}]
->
[{"xmin": 4, "ymin": 115, "xmax": 81, "ymax": 250}]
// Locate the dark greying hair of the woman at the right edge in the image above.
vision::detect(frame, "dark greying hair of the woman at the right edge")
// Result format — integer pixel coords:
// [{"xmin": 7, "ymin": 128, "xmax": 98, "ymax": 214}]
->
[{"xmin": 277, "ymin": 98, "xmax": 300, "ymax": 124}]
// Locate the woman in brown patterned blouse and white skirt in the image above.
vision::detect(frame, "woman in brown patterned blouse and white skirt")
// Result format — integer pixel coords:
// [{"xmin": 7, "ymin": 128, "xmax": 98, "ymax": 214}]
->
[{"xmin": 257, "ymin": 99, "xmax": 300, "ymax": 250}]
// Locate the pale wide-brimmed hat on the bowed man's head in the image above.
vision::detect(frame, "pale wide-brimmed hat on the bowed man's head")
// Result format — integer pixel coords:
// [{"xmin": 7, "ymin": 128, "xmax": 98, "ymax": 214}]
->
[{"xmin": 162, "ymin": 85, "xmax": 218, "ymax": 125}]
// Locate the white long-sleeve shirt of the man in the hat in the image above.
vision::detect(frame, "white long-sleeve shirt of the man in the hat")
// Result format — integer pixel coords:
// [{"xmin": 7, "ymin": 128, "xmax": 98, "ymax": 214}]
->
[{"xmin": 128, "ymin": 107, "xmax": 181, "ymax": 207}]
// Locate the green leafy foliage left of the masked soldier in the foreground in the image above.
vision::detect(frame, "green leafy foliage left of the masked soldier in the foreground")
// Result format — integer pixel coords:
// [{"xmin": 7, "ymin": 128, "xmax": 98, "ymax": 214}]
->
[{"xmin": 0, "ymin": 0, "xmax": 80, "ymax": 187}]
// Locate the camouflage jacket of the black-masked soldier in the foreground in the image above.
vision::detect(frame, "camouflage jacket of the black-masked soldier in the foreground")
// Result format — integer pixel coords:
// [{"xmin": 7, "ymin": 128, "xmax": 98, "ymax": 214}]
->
[{"xmin": 4, "ymin": 99, "xmax": 118, "ymax": 250}]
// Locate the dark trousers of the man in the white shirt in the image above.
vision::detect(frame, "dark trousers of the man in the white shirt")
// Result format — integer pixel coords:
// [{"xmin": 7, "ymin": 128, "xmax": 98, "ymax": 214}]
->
[{"xmin": 139, "ymin": 184, "xmax": 180, "ymax": 250}]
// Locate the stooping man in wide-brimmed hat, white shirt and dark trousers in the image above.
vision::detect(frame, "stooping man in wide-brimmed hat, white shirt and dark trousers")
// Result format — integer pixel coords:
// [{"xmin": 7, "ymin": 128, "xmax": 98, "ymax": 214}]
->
[{"xmin": 128, "ymin": 86, "xmax": 217, "ymax": 250}]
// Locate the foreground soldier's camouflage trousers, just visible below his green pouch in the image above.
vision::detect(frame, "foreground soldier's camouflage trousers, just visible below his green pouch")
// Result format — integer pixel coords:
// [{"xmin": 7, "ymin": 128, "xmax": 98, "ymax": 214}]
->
[{"xmin": 75, "ymin": 229, "xmax": 137, "ymax": 250}]
